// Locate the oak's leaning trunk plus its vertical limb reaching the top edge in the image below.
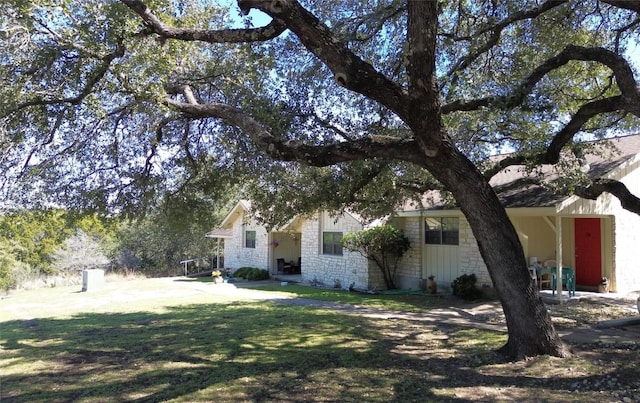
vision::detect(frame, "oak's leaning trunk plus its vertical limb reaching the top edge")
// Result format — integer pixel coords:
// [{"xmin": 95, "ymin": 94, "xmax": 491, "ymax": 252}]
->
[{"xmin": 403, "ymin": 0, "xmax": 568, "ymax": 358}]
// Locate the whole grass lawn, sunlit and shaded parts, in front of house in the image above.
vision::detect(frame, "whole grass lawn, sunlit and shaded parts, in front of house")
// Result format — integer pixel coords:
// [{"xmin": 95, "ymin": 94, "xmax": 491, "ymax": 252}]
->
[{"xmin": 0, "ymin": 280, "xmax": 637, "ymax": 403}]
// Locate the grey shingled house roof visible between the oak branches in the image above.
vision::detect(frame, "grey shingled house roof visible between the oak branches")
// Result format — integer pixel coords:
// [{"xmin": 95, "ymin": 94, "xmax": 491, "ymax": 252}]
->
[{"xmin": 401, "ymin": 135, "xmax": 640, "ymax": 212}]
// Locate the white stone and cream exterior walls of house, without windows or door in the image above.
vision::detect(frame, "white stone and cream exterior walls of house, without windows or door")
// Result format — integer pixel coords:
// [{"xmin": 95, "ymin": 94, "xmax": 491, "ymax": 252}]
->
[{"xmin": 225, "ymin": 148, "xmax": 640, "ymax": 293}]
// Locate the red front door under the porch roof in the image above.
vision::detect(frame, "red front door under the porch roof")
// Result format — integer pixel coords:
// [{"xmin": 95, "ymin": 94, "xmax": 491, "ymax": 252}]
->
[{"xmin": 575, "ymin": 218, "xmax": 602, "ymax": 286}]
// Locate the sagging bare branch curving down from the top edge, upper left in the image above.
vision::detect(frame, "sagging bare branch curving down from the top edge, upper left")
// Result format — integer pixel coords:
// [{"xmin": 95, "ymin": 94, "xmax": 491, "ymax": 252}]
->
[{"xmin": 121, "ymin": 0, "xmax": 287, "ymax": 43}]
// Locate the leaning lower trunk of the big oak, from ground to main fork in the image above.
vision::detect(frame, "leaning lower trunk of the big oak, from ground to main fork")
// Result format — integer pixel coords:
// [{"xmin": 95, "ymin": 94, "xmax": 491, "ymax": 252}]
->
[{"xmin": 429, "ymin": 142, "xmax": 569, "ymax": 359}]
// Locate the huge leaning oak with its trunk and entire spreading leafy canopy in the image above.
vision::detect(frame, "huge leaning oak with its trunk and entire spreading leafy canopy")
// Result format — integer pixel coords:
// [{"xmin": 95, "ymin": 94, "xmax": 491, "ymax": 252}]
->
[{"xmin": 0, "ymin": 0, "xmax": 640, "ymax": 357}]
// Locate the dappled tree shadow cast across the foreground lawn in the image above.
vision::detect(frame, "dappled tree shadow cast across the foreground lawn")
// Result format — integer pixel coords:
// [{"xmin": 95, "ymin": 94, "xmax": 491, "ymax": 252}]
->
[{"xmin": 0, "ymin": 302, "xmax": 636, "ymax": 402}]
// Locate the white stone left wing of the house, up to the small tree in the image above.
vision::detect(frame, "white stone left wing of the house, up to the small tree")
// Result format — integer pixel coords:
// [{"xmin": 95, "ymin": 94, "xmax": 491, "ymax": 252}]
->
[{"xmin": 206, "ymin": 200, "xmax": 384, "ymax": 288}]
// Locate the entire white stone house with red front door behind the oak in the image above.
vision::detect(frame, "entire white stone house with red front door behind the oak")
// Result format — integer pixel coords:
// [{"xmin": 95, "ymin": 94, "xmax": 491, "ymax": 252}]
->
[{"xmin": 208, "ymin": 135, "xmax": 640, "ymax": 292}]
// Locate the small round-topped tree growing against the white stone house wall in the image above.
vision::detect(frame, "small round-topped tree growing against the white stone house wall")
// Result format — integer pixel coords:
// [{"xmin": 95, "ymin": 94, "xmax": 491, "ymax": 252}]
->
[{"xmin": 342, "ymin": 225, "xmax": 411, "ymax": 289}]
